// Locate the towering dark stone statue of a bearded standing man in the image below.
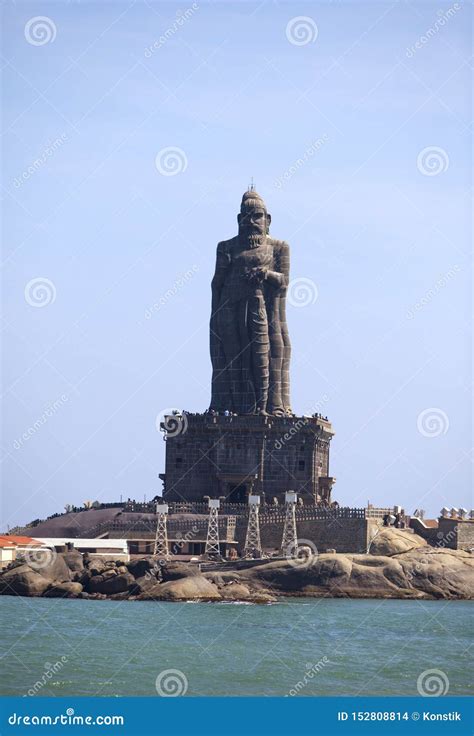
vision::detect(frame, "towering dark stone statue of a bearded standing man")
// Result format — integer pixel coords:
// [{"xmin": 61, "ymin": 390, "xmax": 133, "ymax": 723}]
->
[{"xmin": 210, "ymin": 186, "xmax": 293, "ymax": 416}]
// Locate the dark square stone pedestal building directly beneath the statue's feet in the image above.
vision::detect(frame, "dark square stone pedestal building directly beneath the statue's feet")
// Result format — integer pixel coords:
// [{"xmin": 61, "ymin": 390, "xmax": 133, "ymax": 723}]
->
[{"xmin": 160, "ymin": 412, "xmax": 335, "ymax": 505}]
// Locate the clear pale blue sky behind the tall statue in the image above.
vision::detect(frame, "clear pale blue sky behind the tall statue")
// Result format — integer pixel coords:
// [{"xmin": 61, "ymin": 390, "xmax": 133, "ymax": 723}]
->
[{"xmin": 1, "ymin": 0, "xmax": 472, "ymax": 529}]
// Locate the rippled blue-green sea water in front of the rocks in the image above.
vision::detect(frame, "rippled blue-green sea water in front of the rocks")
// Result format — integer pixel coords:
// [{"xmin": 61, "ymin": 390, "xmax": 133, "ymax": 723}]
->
[{"xmin": 0, "ymin": 596, "xmax": 474, "ymax": 697}]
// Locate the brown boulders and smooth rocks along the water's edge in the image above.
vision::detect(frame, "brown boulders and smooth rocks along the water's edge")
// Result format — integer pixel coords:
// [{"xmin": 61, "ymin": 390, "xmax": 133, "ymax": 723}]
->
[{"xmin": 0, "ymin": 529, "xmax": 474, "ymax": 604}]
